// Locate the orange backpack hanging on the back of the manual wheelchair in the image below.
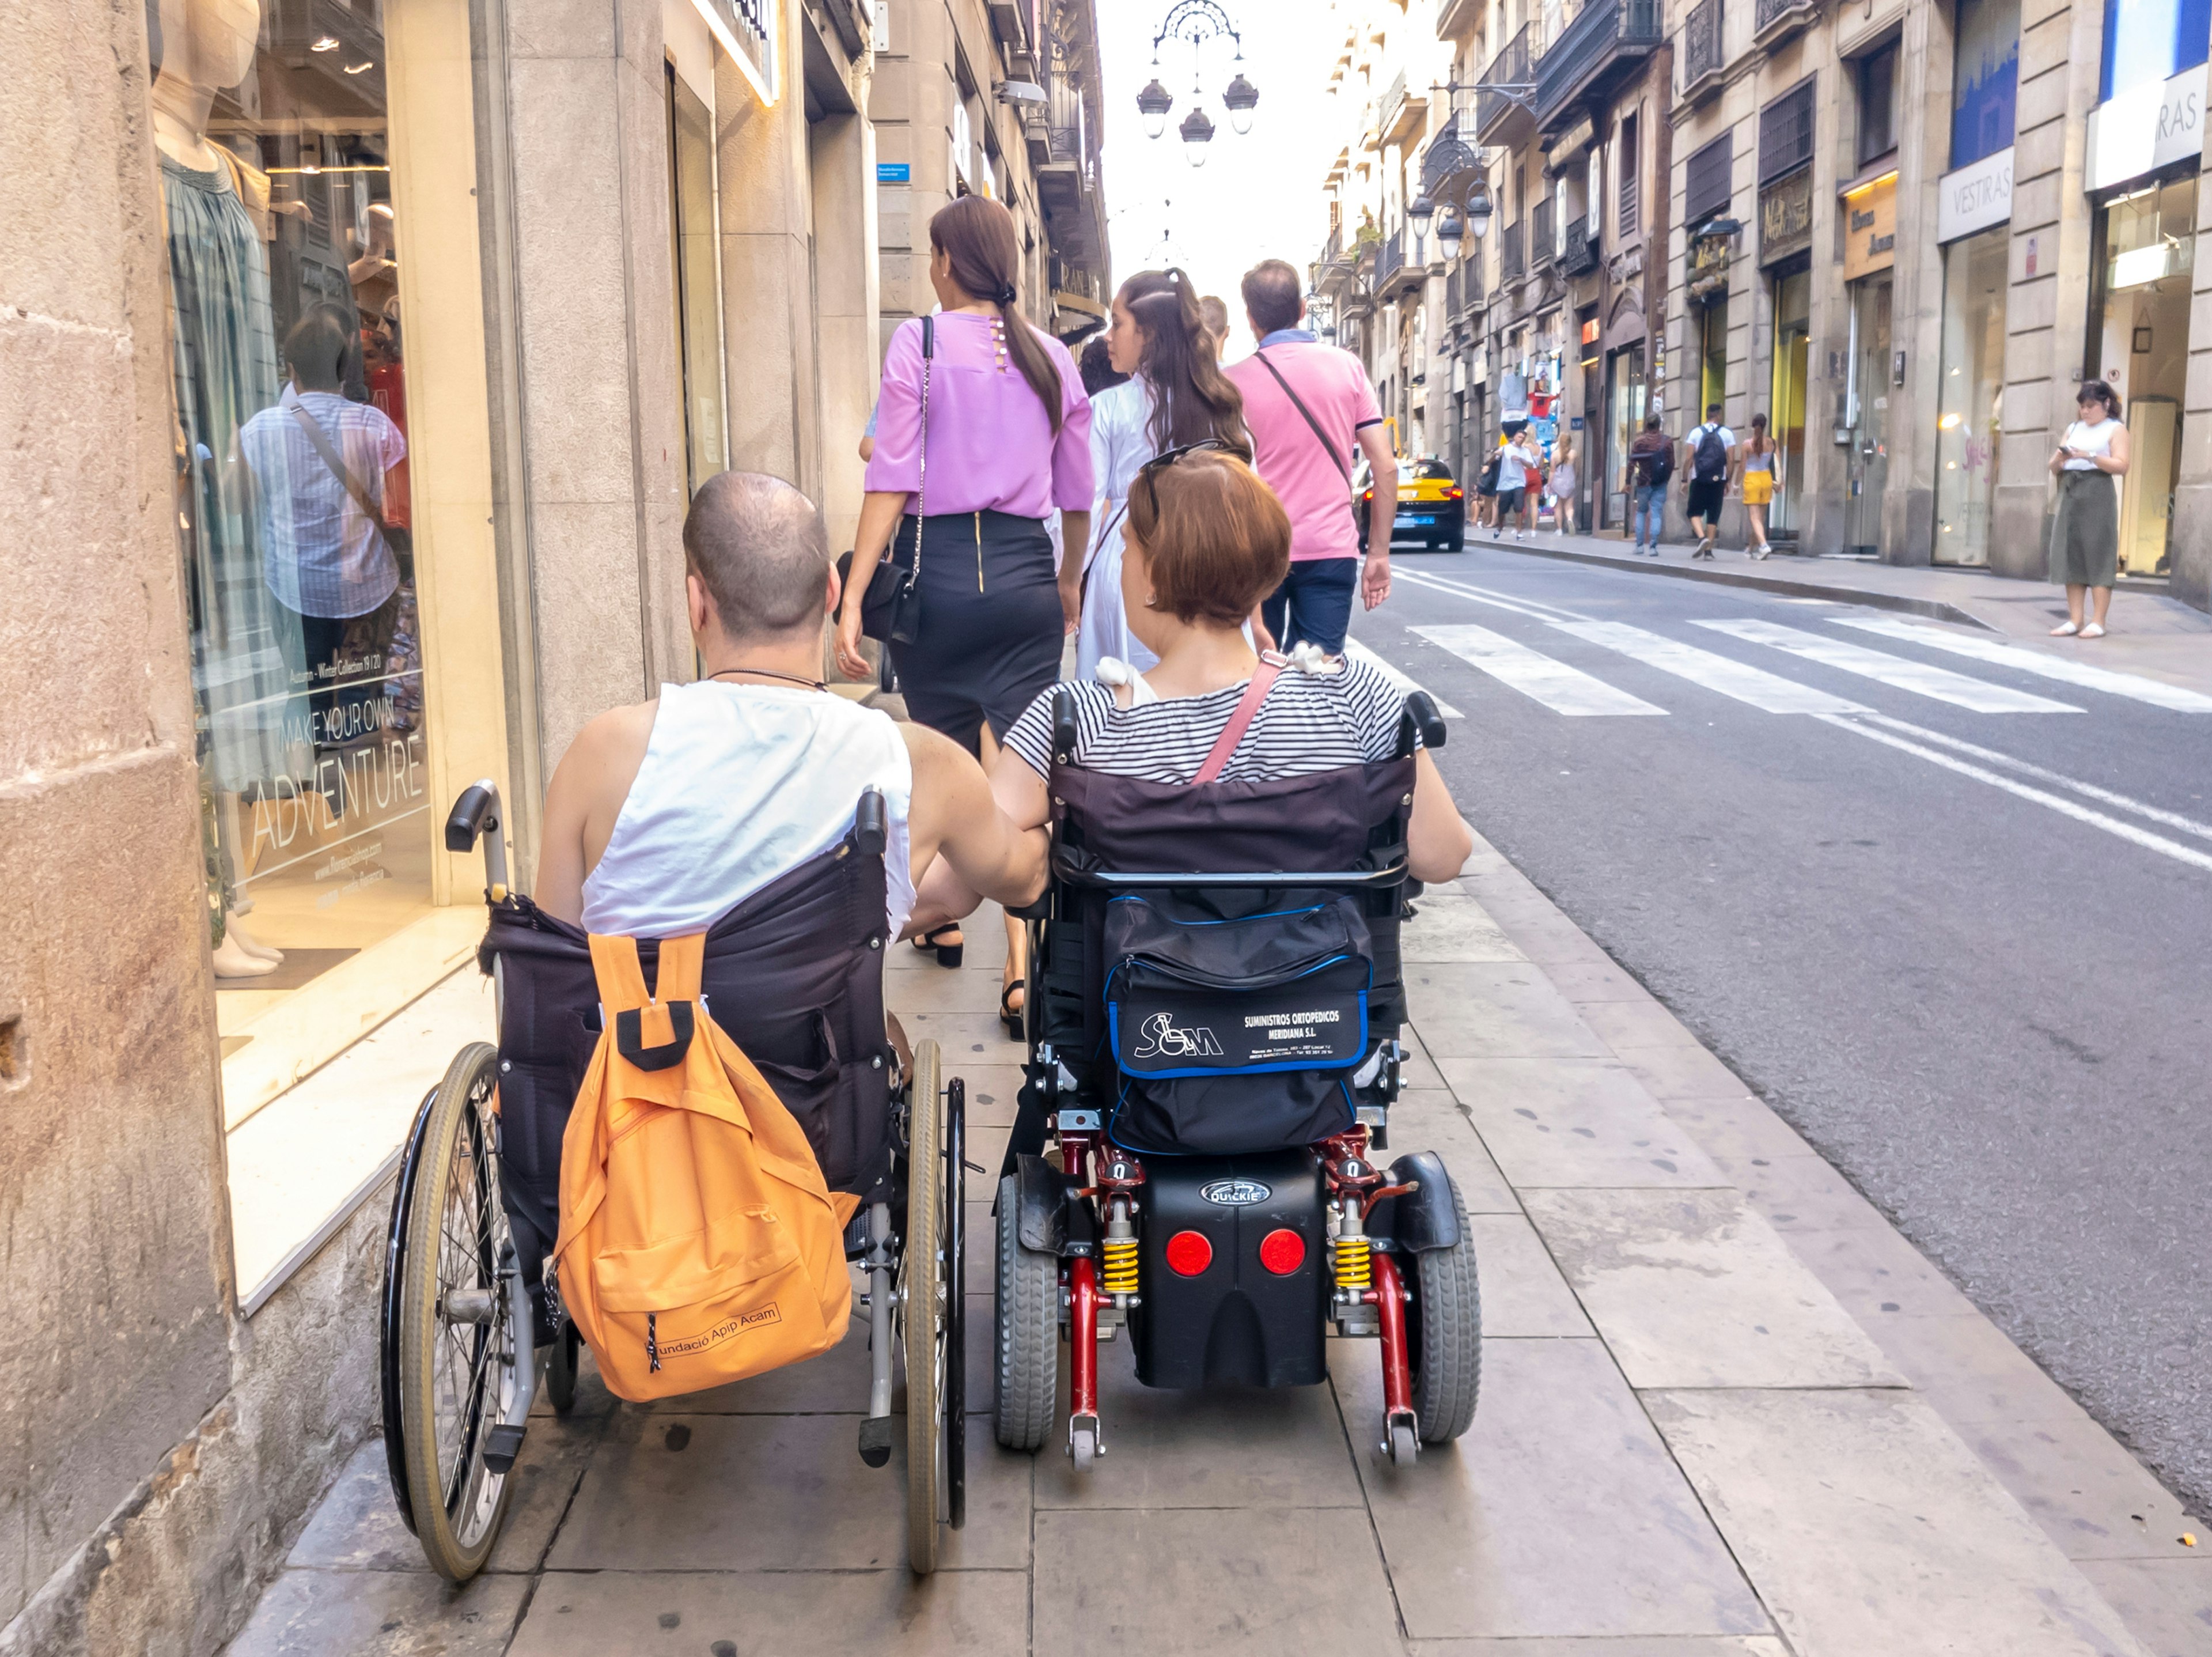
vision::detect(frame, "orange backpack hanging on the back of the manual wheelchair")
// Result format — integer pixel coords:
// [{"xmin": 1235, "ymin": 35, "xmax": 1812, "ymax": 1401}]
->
[{"xmin": 555, "ymin": 933, "xmax": 858, "ymax": 1401}]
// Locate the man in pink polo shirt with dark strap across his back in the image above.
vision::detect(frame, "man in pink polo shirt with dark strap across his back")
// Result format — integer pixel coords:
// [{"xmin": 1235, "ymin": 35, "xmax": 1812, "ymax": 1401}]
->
[{"xmin": 1224, "ymin": 259, "xmax": 1398, "ymax": 655}]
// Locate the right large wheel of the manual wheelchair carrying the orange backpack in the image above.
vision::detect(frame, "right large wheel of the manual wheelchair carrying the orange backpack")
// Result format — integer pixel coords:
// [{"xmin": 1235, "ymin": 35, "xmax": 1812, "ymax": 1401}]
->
[{"xmin": 898, "ymin": 1042, "xmax": 945, "ymax": 1577}]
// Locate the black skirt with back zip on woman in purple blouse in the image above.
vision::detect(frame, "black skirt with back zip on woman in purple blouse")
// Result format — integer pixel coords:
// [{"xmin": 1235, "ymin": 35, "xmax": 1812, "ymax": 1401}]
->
[{"xmin": 889, "ymin": 511, "xmax": 1066, "ymax": 756}]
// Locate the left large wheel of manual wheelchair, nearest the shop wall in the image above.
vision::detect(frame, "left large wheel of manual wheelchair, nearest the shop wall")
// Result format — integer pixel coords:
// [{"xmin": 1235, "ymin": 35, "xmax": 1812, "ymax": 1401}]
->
[{"xmin": 385, "ymin": 1042, "xmax": 522, "ymax": 1582}]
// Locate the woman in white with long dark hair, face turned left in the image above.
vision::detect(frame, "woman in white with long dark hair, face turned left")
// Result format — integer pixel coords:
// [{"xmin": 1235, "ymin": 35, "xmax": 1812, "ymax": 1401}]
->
[{"xmin": 1075, "ymin": 270, "xmax": 1252, "ymax": 683}]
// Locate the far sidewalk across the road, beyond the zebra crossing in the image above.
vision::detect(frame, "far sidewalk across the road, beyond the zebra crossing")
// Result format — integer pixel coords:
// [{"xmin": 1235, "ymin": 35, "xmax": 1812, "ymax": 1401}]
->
[{"xmin": 1451, "ymin": 529, "xmax": 2212, "ymax": 690}]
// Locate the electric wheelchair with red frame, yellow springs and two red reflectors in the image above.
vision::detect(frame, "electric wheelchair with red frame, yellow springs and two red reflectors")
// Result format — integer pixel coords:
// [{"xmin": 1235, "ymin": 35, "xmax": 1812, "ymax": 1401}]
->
[{"xmin": 993, "ymin": 690, "xmax": 1482, "ymax": 1471}]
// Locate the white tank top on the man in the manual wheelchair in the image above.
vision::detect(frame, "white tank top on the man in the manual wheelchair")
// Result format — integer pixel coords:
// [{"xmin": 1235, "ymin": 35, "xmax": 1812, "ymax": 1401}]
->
[{"xmin": 584, "ymin": 679, "xmax": 914, "ymax": 938}]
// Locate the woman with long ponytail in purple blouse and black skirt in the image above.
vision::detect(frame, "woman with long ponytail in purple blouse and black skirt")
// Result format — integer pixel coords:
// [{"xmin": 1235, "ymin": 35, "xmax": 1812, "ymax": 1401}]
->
[{"xmin": 836, "ymin": 195, "xmax": 1093, "ymax": 1004}]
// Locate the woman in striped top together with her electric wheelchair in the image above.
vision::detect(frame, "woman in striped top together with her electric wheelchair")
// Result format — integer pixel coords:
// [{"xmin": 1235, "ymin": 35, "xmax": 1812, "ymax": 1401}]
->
[{"xmin": 927, "ymin": 445, "xmax": 1480, "ymax": 1467}]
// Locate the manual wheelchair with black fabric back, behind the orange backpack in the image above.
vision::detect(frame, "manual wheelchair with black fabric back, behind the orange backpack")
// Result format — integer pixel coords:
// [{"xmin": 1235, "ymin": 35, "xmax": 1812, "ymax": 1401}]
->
[{"xmin": 378, "ymin": 781, "xmax": 967, "ymax": 1582}]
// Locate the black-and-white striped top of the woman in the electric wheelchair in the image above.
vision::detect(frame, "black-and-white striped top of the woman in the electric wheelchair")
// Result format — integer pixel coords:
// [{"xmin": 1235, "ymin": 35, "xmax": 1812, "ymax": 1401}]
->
[{"xmin": 1006, "ymin": 657, "xmax": 1404, "ymax": 783}]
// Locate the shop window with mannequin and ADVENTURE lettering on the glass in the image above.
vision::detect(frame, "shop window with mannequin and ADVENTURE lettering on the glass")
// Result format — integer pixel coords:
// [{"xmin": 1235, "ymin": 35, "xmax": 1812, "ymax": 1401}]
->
[{"xmin": 150, "ymin": 0, "xmax": 506, "ymax": 1299}]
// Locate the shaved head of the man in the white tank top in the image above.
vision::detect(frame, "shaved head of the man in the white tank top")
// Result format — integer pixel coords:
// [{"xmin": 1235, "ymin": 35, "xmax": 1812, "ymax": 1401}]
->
[{"xmin": 684, "ymin": 471, "xmax": 830, "ymax": 644}]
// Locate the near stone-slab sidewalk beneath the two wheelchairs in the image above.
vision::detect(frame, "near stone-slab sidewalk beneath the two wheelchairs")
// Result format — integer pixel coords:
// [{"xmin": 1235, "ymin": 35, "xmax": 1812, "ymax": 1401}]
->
[{"xmin": 215, "ymin": 848, "xmax": 2212, "ymax": 1657}]
